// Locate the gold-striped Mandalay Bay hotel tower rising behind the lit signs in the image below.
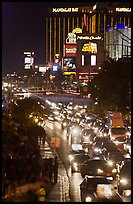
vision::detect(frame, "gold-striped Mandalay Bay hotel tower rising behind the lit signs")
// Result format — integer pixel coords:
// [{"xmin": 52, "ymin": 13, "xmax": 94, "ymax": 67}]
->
[{"xmin": 45, "ymin": 2, "xmax": 131, "ymax": 63}]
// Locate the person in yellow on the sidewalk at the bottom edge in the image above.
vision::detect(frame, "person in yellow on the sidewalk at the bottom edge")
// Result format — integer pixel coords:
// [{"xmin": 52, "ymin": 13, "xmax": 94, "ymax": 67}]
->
[{"xmin": 36, "ymin": 184, "xmax": 46, "ymax": 202}]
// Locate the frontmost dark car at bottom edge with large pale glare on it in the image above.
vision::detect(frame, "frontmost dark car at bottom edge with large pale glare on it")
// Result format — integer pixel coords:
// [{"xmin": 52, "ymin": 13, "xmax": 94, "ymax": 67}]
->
[{"xmin": 80, "ymin": 176, "xmax": 123, "ymax": 202}]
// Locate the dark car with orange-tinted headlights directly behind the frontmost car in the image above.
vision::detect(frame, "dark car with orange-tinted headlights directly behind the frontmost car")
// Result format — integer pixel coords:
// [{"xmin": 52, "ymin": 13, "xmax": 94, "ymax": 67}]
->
[{"xmin": 80, "ymin": 158, "xmax": 118, "ymax": 179}]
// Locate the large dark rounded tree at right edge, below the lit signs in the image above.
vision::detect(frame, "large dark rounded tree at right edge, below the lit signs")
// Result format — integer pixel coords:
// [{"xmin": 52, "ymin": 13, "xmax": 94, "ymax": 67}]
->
[{"xmin": 89, "ymin": 58, "xmax": 131, "ymax": 111}]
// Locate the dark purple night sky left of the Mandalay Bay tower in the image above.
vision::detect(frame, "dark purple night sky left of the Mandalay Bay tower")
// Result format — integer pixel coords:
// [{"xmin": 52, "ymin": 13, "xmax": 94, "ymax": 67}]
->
[{"xmin": 2, "ymin": 2, "xmax": 91, "ymax": 75}]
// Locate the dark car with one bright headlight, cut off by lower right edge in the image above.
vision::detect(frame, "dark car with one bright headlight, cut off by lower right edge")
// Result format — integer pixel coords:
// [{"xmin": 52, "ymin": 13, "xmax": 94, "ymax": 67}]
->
[{"xmin": 118, "ymin": 159, "xmax": 131, "ymax": 194}]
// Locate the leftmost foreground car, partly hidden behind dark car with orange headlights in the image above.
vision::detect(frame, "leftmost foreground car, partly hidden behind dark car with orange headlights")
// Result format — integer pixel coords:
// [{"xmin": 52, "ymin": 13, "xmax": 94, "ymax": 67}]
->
[{"xmin": 71, "ymin": 154, "xmax": 90, "ymax": 173}]
